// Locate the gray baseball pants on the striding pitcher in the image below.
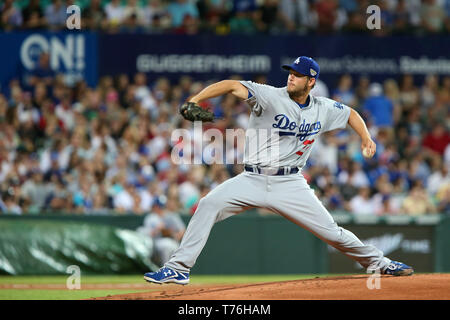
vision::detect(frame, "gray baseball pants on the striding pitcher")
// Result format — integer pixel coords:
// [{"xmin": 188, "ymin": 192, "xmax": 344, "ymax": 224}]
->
[{"xmin": 165, "ymin": 172, "xmax": 390, "ymax": 272}]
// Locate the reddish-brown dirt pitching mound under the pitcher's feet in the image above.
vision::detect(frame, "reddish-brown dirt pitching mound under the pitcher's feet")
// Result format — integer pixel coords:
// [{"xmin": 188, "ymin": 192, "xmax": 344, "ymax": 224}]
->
[{"xmin": 89, "ymin": 274, "xmax": 450, "ymax": 300}]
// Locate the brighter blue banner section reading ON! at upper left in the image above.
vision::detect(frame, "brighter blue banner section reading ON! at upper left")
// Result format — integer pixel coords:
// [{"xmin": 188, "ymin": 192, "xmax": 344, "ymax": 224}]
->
[{"xmin": 0, "ymin": 31, "xmax": 98, "ymax": 89}]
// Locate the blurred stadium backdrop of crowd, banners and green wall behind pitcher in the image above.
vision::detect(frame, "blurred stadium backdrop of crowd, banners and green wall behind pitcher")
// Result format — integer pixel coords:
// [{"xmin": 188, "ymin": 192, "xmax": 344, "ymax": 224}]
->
[{"xmin": 0, "ymin": 0, "xmax": 450, "ymax": 274}]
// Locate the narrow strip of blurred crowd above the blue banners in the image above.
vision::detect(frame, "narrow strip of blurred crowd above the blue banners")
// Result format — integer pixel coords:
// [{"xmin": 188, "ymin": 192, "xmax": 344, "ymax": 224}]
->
[{"xmin": 0, "ymin": 0, "xmax": 450, "ymax": 36}]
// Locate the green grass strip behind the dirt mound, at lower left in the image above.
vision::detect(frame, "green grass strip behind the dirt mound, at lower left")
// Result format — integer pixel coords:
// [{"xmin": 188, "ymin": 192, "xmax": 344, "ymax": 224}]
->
[{"xmin": 0, "ymin": 274, "xmax": 326, "ymax": 300}]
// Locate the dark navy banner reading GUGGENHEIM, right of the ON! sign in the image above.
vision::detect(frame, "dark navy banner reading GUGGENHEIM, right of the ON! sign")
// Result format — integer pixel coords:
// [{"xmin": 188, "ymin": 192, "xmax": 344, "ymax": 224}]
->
[{"xmin": 99, "ymin": 34, "xmax": 450, "ymax": 85}]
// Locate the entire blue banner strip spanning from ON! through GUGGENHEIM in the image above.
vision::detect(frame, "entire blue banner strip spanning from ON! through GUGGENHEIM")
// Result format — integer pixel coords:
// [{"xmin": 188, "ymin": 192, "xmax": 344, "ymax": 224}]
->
[{"xmin": 0, "ymin": 31, "xmax": 450, "ymax": 88}]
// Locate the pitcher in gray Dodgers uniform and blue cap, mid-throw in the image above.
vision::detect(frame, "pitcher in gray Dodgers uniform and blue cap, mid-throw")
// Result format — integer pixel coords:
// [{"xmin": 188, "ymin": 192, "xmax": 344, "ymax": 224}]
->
[{"xmin": 144, "ymin": 56, "xmax": 413, "ymax": 284}]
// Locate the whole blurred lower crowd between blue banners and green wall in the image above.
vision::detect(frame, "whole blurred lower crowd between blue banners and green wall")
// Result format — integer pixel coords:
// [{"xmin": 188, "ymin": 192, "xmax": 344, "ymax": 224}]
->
[{"xmin": 0, "ymin": 48, "xmax": 450, "ymax": 216}]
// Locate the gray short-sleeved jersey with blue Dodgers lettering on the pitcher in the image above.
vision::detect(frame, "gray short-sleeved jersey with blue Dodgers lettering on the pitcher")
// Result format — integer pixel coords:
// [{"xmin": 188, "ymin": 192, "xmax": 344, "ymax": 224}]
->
[{"xmin": 241, "ymin": 81, "xmax": 350, "ymax": 168}]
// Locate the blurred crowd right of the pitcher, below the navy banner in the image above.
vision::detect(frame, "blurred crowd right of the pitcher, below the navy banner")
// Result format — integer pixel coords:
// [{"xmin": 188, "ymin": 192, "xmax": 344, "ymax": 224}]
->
[{"xmin": 306, "ymin": 74, "xmax": 450, "ymax": 216}]
